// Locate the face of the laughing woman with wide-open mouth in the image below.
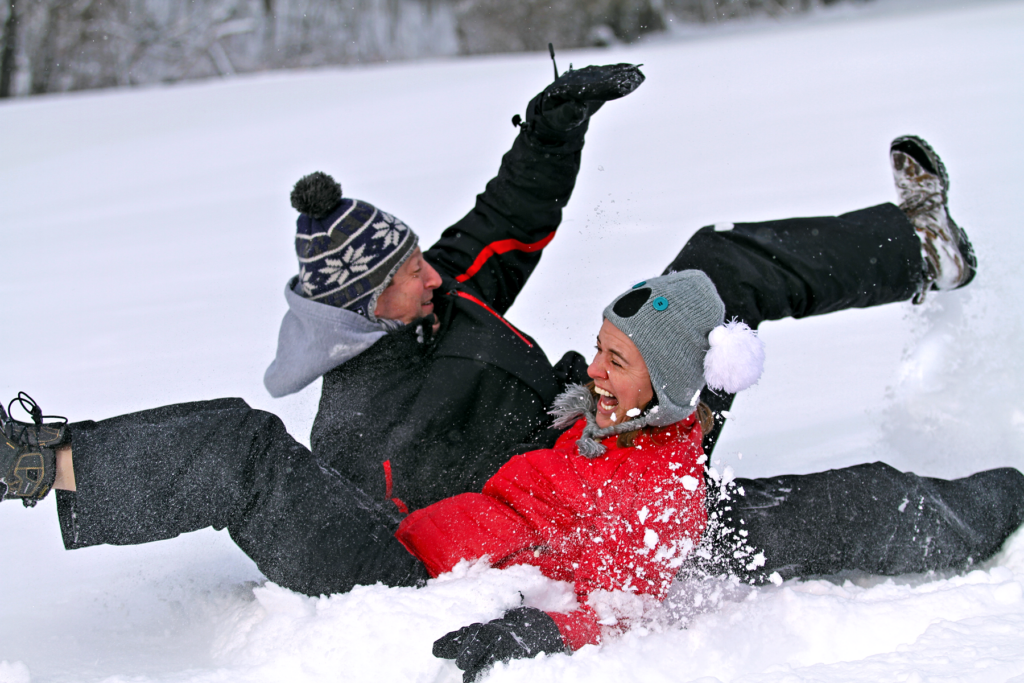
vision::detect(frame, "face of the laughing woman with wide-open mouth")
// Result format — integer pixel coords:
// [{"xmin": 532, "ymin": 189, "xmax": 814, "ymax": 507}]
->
[{"xmin": 587, "ymin": 321, "xmax": 654, "ymax": 427}]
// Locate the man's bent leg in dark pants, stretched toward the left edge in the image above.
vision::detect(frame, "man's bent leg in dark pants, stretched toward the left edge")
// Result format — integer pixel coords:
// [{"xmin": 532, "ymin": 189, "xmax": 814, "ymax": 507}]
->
[{"xmin": 57, "ymin": 398, "xmax": 427, "ymax": 595}]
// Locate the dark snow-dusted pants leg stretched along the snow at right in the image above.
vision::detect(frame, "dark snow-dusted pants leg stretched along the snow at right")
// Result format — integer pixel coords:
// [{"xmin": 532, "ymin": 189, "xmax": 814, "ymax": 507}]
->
[{"xmin": 716, "ymin": 463, "xmax": 1024, "ymax": 581}]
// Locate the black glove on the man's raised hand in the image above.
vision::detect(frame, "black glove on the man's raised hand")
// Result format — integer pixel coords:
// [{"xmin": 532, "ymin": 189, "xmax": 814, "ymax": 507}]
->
[{"xmin": 540, "ymin": 65, "xmax": 644, "ymax": 130}]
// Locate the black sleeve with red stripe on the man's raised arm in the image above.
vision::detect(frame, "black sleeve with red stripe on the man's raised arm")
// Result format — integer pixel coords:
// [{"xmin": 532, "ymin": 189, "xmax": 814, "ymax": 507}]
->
[{"xmin": 425, "ymin": 95, "xmax": 589, "ymax": 314}]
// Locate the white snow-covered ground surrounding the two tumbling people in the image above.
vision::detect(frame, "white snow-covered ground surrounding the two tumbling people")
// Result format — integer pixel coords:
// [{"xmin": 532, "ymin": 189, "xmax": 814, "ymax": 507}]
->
[{"xmin": 0, "ymin": 2, "xmax": 1024, "ymax": 683}]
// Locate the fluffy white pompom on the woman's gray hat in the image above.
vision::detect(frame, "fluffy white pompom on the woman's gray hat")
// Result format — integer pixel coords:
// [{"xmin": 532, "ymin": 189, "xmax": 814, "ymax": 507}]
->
[{"xmin": 705, "ymin": 321, "xmax": 765, "ymax": 393}]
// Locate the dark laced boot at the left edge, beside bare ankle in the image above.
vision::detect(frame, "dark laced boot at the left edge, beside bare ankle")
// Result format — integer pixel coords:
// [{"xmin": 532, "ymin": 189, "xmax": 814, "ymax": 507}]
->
[{"xmin": 0, "ymin": 391, "xmax": 68, "ymax": 507}]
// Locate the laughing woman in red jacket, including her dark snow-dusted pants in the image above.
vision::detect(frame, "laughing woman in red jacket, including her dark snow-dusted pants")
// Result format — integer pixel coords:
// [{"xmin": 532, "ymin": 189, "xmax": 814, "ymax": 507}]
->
[{"xmin": 395, "ymin": 270, "xmax": 1024, "ymax": 681}]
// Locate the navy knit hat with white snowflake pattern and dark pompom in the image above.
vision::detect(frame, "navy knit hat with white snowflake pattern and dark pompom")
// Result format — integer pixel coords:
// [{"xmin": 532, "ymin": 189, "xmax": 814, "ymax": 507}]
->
[{"xmin": 292, "ymin": 171, "xmax": 418, "ymax": 323}]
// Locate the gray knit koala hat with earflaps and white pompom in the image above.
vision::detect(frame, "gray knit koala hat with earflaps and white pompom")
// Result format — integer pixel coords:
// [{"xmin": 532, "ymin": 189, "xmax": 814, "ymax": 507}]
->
[{"xmin": 551, "ymin": 270, "xmax": 764, "ymax": 457}]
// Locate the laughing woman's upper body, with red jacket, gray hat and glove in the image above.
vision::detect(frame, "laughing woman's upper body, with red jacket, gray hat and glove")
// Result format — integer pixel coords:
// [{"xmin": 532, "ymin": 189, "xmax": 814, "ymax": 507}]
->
[{"xmin": 395, "ymin": 270, "xmax": 764, "ymax": 678}]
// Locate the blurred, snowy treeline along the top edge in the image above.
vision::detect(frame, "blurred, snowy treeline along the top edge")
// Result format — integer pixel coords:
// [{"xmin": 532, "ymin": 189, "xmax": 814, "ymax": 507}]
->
[{"xmin": 0, "ymin": 0, "xmax": 856, "ymax": 97}]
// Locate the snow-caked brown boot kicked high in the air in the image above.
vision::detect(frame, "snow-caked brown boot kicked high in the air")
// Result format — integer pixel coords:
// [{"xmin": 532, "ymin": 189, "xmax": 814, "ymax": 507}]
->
[{"xmin": 889, "ymin": 135, "xmax": 978, "ymax": 303}]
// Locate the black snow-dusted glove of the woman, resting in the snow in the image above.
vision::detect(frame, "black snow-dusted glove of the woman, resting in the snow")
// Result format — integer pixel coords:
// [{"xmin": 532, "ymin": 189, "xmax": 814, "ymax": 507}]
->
[{"xmin": 433, "ymin": 607, "xmax": 567, "ymax": 683}]
